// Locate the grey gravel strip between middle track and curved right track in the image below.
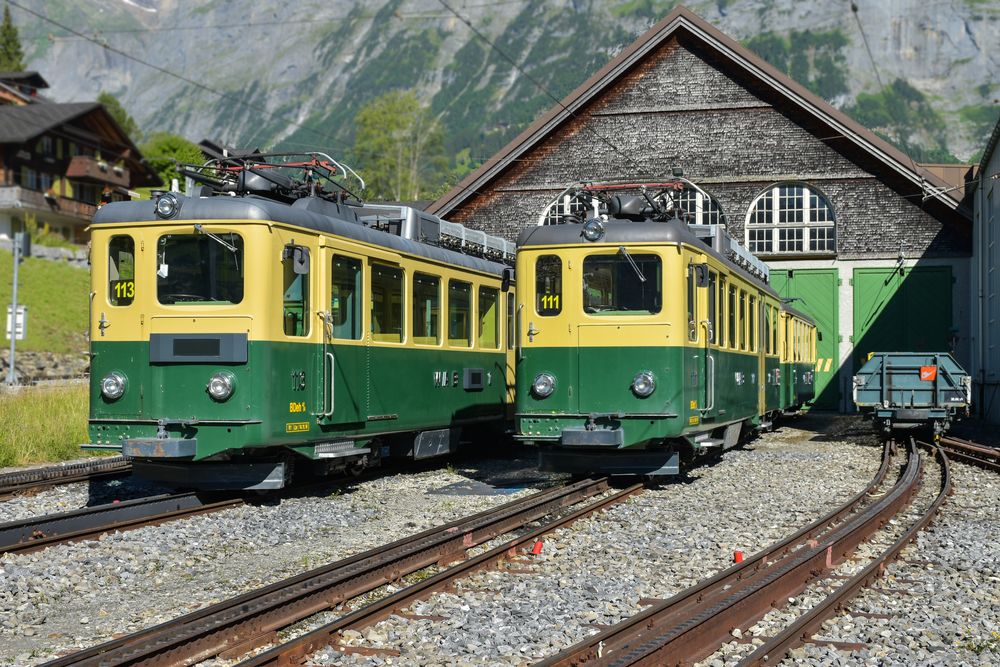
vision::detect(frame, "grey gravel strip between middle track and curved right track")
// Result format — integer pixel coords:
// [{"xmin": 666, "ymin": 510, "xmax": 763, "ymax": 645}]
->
[{"xmin": 302, "ymin": 420, "xmax": 881, "ymax": 665}]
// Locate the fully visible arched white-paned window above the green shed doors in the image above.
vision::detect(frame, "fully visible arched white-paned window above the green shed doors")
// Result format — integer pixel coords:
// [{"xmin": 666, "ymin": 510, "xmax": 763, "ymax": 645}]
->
[{"xmin": 746, "ymin": 183, "xmax": 837, "ymax": 255}]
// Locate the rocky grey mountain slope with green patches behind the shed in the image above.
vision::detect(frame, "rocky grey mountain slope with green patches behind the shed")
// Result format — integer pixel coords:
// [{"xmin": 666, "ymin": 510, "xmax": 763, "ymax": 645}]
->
[{"xmin": 12, "ymin": 0, "xmax": 1000, "ymax": 164}]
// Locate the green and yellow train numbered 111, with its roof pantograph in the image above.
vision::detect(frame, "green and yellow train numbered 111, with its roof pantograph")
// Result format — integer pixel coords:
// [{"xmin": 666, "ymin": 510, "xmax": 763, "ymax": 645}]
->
[{"xmin": 515, "ymin": 182, "xmax": 816, "ymax": 475}]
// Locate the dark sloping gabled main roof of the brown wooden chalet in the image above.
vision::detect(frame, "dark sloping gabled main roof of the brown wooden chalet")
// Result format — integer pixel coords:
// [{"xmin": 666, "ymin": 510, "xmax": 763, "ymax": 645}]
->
[{"xmin": 0, "ymin": 102, "xmax": 160, "ymax": 187}]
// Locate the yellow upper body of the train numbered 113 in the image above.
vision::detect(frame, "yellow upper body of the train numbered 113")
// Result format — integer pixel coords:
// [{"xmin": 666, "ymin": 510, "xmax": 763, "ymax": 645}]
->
[{"xmin": 90, "ymin": 220, "xmax": 507, "ymax": 351}]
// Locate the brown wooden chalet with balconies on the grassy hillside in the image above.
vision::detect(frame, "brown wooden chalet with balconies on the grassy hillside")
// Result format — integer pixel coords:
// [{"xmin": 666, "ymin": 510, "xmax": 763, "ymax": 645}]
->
[{"xmin": 0, "ymin": 72, "xmax": 159, "ymax": 242}]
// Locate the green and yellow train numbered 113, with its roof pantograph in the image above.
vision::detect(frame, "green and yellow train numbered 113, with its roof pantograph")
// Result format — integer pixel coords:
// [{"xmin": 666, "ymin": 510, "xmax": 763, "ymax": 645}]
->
[{"xmin": 90, "ymin": 154, "xmax": 514, "ymax": 489}]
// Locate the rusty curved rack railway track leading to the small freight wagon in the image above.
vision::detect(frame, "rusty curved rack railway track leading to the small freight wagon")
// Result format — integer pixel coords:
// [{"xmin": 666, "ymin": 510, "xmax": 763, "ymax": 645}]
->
[{"xmin": 537, "ymin": 440, "xmax": 951, "ymax": 667}]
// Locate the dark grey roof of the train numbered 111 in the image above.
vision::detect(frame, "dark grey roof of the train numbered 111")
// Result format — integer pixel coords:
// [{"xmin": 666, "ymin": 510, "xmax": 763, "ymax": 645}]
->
[{"xmin": 517, "ymin": 218, "xmax": 784, "ymax": 302}]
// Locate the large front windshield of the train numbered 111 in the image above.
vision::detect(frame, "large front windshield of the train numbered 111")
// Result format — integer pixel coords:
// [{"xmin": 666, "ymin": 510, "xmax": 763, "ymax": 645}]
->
[{"xmin": 583, "ymin": 252, "xmax": 663, "ymax": 315}]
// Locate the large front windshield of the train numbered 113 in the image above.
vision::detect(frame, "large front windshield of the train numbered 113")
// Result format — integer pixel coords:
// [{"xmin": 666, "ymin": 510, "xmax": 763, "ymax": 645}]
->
[{"xmin": 156, "ymin": 232, "xmax": 244, "ymax": 305}]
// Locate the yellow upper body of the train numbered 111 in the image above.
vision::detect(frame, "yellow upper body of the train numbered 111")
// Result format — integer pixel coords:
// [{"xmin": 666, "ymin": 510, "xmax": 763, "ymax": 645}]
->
[{"xmin": 517, "ymin": 242, "xmax": 779, "ymax": 355}]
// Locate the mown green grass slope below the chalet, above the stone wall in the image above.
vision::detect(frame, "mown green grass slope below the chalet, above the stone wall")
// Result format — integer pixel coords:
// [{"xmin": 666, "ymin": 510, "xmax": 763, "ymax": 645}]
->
[{"xmin": 0, "ymin": 250, "xmax": 90, "ymax": 353}]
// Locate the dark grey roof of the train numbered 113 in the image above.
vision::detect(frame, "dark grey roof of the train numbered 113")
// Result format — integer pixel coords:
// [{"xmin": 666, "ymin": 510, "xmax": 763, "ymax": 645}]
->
[{"xmin": 92, "ymin": 193, "xmax": 508, "ymax": 275}]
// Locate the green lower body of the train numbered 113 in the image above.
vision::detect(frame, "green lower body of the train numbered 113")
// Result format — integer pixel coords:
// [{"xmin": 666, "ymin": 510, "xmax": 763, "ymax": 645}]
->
[{"xmin": 90, "ymin": 341, "xmax": 506, "ymax": 461}]
